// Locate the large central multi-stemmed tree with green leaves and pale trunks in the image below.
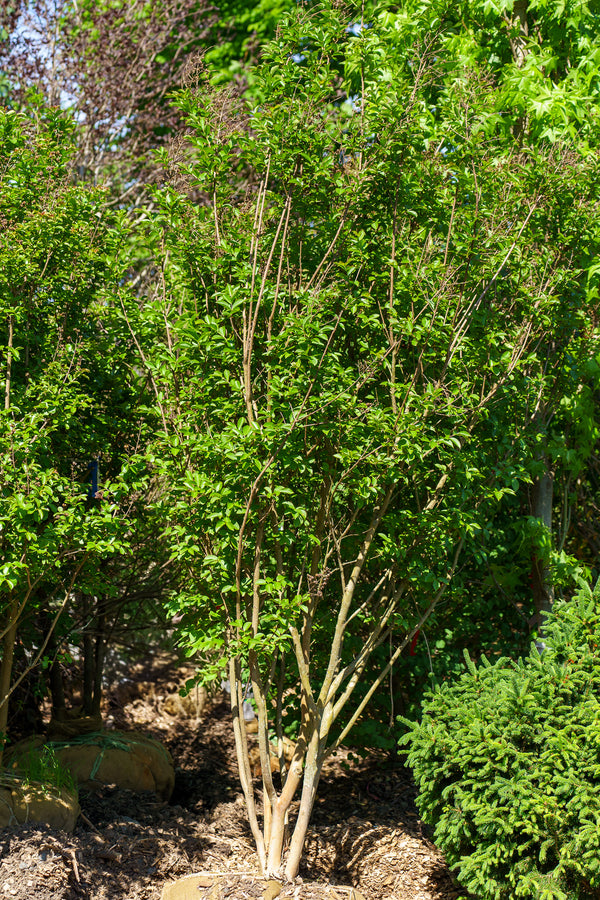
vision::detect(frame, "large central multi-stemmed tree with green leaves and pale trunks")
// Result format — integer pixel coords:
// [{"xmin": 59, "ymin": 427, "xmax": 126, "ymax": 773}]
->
[{"xmin": 123, "ymin": 5, "xmax": 600, "ymax": 878}]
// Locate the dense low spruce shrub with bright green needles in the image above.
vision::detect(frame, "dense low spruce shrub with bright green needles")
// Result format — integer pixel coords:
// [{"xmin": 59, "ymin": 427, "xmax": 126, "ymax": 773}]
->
[{"xmin": 401, "ymin": 580, "xmax": 600, "ymax": 900}]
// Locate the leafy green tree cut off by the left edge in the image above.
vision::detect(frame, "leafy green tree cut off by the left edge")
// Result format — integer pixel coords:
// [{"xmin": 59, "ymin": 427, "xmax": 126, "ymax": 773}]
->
[{"xmin": 0, "ymin": 107, "xmax": 151, "ymax": 760}]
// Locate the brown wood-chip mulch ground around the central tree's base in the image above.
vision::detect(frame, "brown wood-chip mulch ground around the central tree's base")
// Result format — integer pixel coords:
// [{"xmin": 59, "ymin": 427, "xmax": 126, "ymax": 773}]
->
[{"xmin": 0, "ymin": 664, "xmax": 460, "ymax": 900}]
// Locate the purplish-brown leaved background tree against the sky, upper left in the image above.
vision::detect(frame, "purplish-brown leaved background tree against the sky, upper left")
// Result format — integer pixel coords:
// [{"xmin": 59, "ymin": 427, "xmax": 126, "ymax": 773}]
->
[{"xmin": 0, "ymin": 0, "xmax": 215, "ymax": 207}]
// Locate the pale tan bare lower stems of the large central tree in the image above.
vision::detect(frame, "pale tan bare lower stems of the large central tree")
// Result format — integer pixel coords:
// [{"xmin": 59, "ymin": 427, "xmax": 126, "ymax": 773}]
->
[{"xmin": 229, "ymin": 488, "xmax": 463, "ymax": 880}]
